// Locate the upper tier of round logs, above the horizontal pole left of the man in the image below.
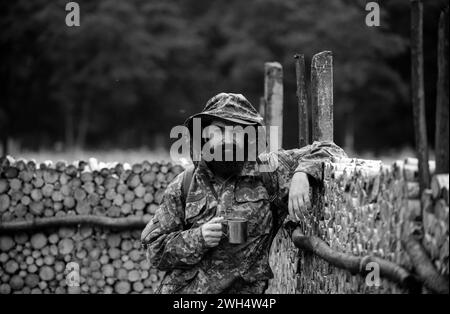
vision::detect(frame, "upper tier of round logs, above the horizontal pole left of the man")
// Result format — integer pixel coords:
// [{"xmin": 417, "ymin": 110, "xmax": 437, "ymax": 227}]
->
[{"xmin": 0, "ymin": 158, "xmax": 182, "ymax": 222}]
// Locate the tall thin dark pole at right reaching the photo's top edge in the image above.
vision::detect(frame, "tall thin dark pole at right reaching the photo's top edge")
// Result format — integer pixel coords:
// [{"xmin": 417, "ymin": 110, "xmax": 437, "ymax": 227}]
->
[{"xmin": 411, "ymin": 0, "xmax": 430, "ymax": 192}]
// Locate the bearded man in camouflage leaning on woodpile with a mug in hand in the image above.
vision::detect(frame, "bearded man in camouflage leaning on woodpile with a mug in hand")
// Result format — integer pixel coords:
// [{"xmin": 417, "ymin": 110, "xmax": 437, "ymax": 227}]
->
[{"xmin": 142, "ymin": 93, "xmax": 346, "ymax": 293}]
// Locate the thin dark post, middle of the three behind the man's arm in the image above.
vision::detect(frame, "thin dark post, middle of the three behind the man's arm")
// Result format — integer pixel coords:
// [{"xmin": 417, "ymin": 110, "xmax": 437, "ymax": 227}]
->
[{"xmin": 294, "ymin": 54, "xmax": 309, "ymax": 148}]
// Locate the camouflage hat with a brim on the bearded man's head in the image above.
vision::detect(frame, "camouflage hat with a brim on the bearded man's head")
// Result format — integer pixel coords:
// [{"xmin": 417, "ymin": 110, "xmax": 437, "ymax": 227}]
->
[{"xmin": 185, "ymin": 93, "xmax": 264, "ymax": 130}]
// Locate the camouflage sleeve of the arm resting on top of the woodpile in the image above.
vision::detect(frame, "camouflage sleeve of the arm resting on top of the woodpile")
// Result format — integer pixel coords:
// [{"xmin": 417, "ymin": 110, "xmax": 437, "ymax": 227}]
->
[{"xmin": 262, "ymin": 141, "xmax": 347, "ymax": 205}]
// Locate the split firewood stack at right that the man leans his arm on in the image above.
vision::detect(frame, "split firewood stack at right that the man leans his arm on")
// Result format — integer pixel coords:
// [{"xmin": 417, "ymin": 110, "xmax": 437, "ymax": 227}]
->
[{"xmin": 268, "ymin": 158, "xmax": 448, "ymax": 293}]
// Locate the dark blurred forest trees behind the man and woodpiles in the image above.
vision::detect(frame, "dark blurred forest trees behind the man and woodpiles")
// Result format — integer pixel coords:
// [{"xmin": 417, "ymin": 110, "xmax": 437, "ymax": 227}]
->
[{"xmin": 0, "ymin": 0, "xmax": 448, "ymax": 153}]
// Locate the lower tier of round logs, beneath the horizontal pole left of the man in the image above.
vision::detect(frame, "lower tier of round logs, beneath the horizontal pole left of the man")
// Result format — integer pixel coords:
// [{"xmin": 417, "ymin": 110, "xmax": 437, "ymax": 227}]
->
[{"xmin": 0, "ymin": 227, "xmax": 163, "ymax": 294}]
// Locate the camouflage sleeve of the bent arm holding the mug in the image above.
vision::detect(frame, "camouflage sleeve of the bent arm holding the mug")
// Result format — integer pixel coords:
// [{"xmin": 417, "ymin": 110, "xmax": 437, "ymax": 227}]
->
[{"xmin": 141, "ymin": 173, "xmax": 208, "ymax": 270}]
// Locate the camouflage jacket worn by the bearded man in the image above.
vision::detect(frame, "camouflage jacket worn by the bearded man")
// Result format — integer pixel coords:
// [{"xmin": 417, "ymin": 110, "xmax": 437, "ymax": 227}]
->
[{"xmin": 142, "ymin": 142, "xmax": 346, "ymax": 293}]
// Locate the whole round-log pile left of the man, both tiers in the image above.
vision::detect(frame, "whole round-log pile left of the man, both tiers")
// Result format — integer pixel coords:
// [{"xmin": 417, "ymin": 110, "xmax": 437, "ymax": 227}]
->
[{"xmin": 0, "ymin": 157, "xmax": 183, "ymax": 294}]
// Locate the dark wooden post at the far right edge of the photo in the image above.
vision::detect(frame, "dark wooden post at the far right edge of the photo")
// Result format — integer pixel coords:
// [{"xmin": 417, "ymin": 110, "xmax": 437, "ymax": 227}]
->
[{"xmin": 435, "ymin": 7, "xmax": 449, "ymax": 174}]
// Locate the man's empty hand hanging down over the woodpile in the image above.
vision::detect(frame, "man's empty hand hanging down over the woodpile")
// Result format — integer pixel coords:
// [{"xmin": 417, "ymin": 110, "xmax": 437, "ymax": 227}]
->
[{"xmin": 288, "ymin": 172, "xmax": 311, "ymax": 221}]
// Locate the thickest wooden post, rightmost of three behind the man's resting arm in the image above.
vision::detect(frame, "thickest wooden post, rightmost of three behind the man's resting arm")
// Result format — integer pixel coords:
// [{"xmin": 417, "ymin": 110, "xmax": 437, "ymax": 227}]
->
[{"xmin": 311, "ymin": 51, "xmax": 333, "ymax": 141}]
